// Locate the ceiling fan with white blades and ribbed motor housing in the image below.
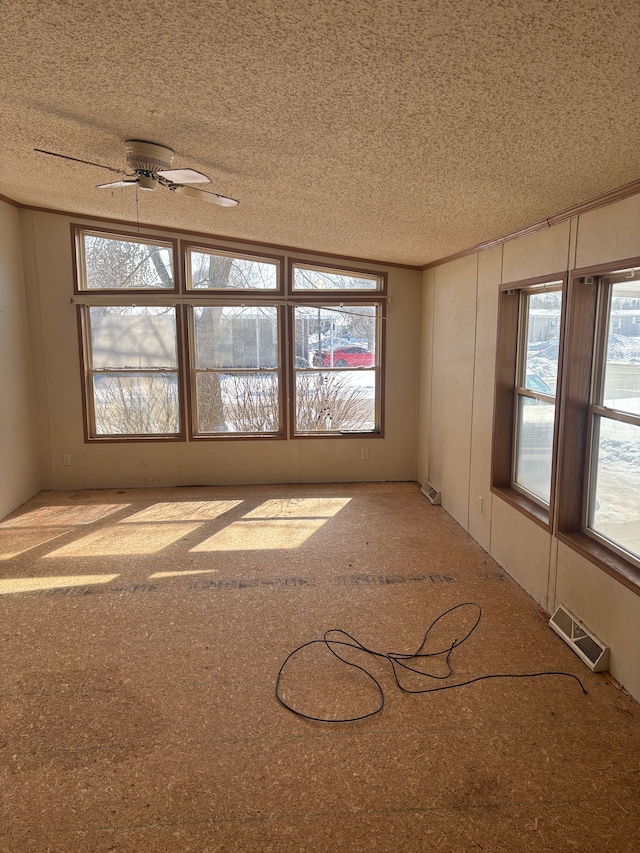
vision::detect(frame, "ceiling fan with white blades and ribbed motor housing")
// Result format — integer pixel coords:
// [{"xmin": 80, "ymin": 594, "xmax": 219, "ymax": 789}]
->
[{"xmin": 34, "ymin": 139, "xmax": 239, "ymax": 207}]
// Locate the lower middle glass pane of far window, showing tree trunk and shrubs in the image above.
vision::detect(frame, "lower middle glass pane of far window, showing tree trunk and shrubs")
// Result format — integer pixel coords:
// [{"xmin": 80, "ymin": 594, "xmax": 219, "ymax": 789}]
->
[{"xmin": 196, "ymin": 371, "xmax": 280, "ymax": 434}]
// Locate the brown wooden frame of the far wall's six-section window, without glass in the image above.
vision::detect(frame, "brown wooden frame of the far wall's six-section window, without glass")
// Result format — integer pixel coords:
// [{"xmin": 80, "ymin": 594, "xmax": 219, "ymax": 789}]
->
[{"xmin": 71, "ymin": 223, "xmax": 387, "ymax": 443}]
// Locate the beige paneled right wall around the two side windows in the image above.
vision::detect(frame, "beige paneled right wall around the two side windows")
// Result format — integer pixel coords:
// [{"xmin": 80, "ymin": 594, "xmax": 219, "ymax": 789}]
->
[{"xmin": 418, "ymin": 195, "xmax": 640, "ymax": 699}]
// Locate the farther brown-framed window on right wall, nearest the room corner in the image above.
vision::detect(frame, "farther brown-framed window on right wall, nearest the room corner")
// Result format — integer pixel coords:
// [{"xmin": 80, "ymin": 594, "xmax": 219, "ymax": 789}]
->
[{"xmin": 492, "ymin": 277, "xmax": 564, "ymax": 527}]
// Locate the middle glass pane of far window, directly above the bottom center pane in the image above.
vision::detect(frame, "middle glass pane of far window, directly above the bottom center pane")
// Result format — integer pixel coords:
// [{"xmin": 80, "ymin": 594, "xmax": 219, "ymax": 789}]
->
[{"xmin": 193, "ymin": 305, "xmax": 278, "ymax": 369}]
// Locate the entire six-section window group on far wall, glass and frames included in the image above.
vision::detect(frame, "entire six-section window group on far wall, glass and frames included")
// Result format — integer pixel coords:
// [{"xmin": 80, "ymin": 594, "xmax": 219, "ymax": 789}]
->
[{"xmin": 73, "ymin": 226, "xmax": 386, "ymax": 441}]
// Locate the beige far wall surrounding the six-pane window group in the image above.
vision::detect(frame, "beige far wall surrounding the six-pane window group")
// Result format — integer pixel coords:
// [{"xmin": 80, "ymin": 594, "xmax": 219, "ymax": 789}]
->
[{"xmin": 21, "ymin": 210, "xmax": 421, "ymax": 489}]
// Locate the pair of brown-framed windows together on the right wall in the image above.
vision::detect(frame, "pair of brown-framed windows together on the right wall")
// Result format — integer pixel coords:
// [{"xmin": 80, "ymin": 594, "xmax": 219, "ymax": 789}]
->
[{"xmin": 492, "ymin": 260, "xmax": 640, "ymax": 593}]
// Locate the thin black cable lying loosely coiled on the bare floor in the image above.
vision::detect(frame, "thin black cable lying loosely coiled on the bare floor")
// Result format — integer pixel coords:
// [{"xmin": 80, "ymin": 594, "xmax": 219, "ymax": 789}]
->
[{"xmin": 275, "ymin": 601, "xmax": 587, "ymax": 723}]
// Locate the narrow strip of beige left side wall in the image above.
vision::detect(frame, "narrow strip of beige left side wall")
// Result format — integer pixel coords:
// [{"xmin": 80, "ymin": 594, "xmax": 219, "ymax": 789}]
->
[{"xmin": 0, "ymin": 201, "xmax": 40, "ymax": 518}]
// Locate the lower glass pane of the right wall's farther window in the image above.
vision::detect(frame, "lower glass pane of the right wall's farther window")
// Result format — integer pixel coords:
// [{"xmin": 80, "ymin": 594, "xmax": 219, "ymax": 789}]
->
[{"xmin": 514, "ymin": 395, "xmax": 555, "ymax": 504}]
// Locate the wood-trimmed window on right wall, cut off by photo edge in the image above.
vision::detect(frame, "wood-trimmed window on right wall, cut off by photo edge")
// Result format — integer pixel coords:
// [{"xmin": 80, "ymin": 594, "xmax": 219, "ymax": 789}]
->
[{"xmin": 557, "ymin": 260, "xmax": 640, "ymax": 580}]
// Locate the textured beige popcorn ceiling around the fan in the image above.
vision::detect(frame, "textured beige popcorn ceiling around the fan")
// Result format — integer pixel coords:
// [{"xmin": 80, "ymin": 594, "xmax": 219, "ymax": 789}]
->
[{"xmin": 0, "ymin": 0, "xmax": 640, "ymax": 264}]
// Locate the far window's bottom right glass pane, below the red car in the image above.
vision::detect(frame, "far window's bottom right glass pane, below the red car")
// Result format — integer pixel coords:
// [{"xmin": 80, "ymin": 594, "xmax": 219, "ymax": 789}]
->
[{"xmin": 296, "ymin": 370, "xmax": 376, "ymax": 433}]
